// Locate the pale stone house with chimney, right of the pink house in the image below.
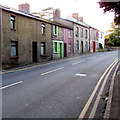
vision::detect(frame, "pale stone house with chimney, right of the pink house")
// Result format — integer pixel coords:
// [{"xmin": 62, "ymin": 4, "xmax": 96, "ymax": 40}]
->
[{"xmin": 66, "ymin": 13, "xmax": 90, "ymax": 55}]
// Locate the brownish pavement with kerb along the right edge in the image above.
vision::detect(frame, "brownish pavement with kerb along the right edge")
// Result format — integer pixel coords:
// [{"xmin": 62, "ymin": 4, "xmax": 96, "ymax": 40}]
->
[{"xmin": 104, "ymin": 60, "xmax": 120, "ymax": 120}]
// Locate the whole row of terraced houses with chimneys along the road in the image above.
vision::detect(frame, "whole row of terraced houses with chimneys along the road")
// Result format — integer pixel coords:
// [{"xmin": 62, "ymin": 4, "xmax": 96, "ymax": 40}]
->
[{"xmin": 0, "ymin": 4, "xmax": 104, "ymax": 68}]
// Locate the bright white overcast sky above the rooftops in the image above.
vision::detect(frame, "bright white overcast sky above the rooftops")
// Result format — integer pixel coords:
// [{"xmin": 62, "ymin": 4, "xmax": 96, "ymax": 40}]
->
[{"xmin": 0, "ymin": 0, "xmax": 114, "ymax": 32}]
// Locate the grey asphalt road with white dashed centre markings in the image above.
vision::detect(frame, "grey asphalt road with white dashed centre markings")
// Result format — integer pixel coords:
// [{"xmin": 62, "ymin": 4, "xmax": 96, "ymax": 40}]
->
[{"xmin": 0, "ymin": 51, "xmax": 118, "ymax": 118}]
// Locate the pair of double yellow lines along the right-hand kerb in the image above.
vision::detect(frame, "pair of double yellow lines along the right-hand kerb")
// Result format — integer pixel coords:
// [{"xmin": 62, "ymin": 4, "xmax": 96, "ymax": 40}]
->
[{"xmin": 78, "ymin": 59, "xmax": 120, "ymax": 119}]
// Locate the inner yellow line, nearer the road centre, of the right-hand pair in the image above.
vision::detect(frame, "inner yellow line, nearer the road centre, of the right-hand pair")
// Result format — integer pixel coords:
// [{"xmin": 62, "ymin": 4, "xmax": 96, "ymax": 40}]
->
[{"xmin": 78, "ymin": 59, "xmax": 118, "ymax": 119}]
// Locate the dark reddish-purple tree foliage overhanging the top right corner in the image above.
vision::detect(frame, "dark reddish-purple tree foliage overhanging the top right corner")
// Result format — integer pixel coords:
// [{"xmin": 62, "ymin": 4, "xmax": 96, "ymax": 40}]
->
[{"xmin": 99, "ymin": 0, "xmax": 120, "ymax": 25}]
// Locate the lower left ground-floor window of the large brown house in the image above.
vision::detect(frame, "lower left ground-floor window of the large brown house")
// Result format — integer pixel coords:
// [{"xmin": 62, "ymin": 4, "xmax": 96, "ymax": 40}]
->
[{"xmin": 11, "ymin": 41, "xmax": 18, "ymax": 56}]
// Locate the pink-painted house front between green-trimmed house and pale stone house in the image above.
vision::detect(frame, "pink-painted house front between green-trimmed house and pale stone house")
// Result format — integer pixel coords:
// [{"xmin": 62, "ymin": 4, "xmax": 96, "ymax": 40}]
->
[{"xmin": 63, "ymin": 28, "xmax": 74, "ymax": 57}]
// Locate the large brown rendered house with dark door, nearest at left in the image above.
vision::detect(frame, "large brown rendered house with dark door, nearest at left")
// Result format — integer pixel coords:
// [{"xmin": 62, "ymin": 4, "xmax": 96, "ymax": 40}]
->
[{"xmin": 0, "ymin": 6, "xmax": 52, "ymax": 67}]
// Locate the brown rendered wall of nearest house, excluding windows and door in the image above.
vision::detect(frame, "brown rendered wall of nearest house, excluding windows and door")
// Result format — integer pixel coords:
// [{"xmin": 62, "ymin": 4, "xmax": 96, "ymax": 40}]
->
[{"xmin": 2, "ymin": 10, "xmax": 52, "ymax": 66}]
